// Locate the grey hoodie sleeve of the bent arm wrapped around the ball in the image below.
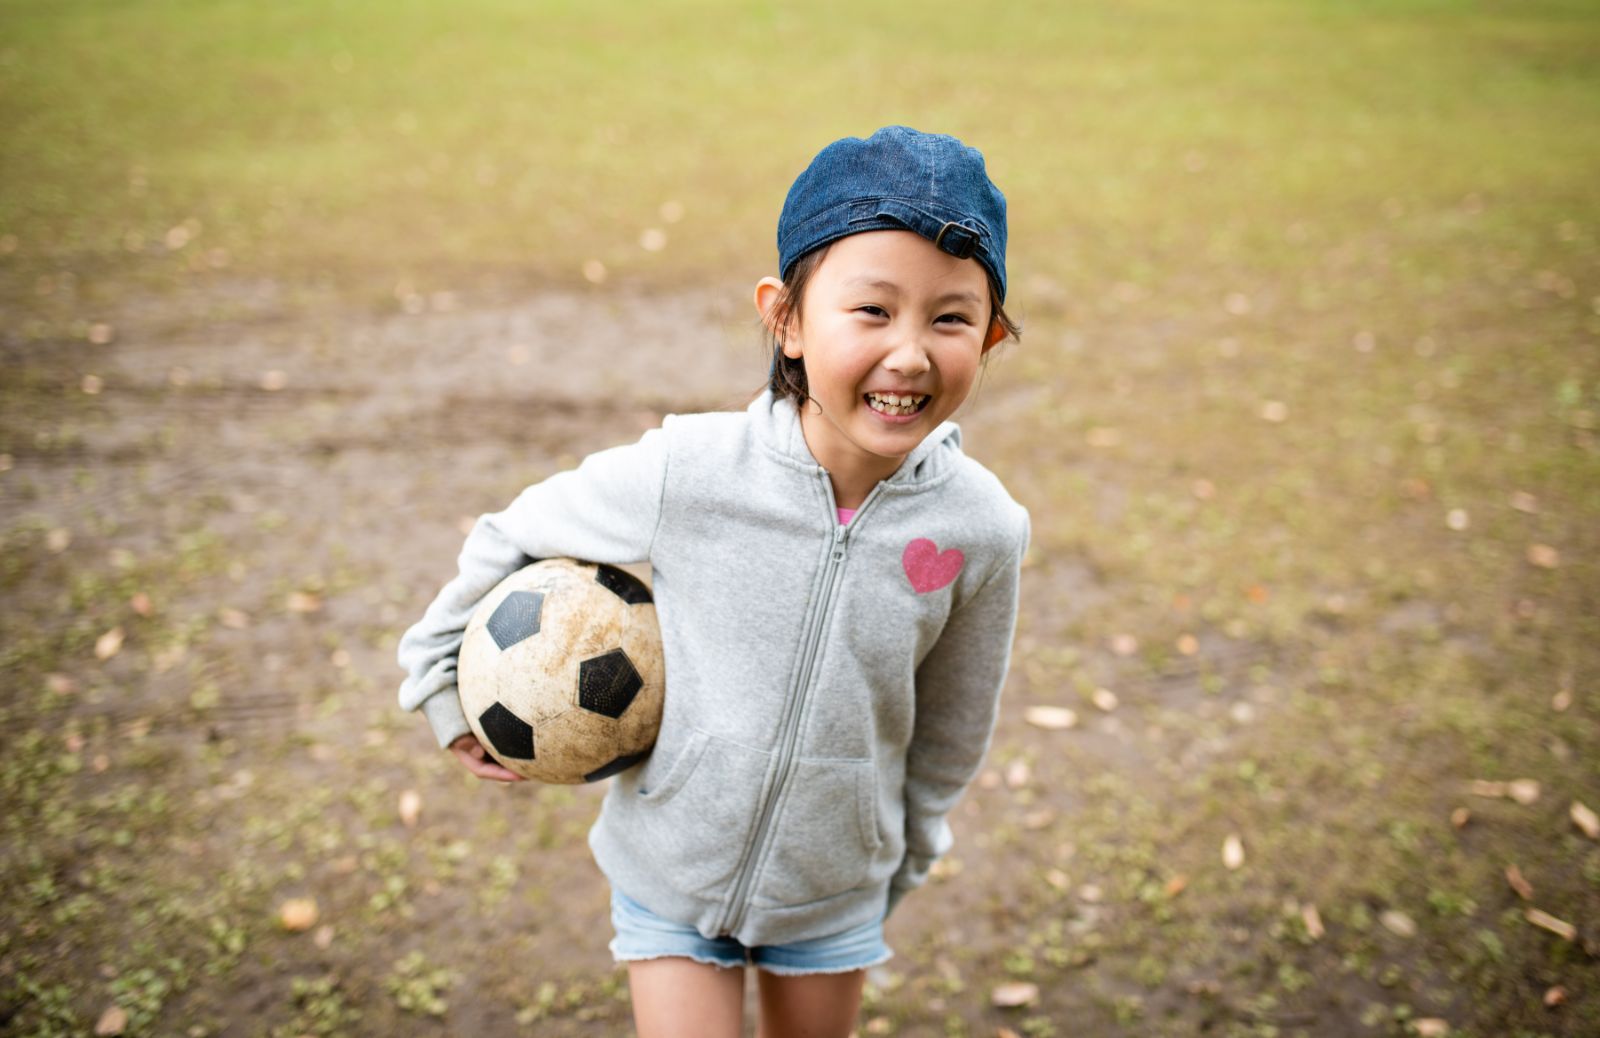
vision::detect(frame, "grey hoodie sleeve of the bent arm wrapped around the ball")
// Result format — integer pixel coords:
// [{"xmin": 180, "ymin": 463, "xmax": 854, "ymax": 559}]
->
[{"xmin": 398, "ymin": 425, "xmax": 667, "ymax": 747}]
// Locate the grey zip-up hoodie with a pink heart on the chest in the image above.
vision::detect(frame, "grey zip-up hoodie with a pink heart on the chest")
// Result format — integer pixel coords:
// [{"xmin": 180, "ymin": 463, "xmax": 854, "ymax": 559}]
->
[{"xmin": 400, "ymin": 392, "xmax": 1029, "ymax": 945}]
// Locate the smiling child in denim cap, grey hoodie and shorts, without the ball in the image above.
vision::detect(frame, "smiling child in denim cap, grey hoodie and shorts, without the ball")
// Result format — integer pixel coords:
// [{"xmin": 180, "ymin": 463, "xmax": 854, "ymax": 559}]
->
[{"xmin": 400, "ymin": 126, "xmax": 1029, "ymax": 1036}]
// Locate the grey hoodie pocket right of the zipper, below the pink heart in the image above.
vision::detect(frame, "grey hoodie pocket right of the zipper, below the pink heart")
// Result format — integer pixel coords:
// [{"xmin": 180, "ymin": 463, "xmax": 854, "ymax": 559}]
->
[{"xmin": 757, "ymin": 758, "xmax": 883, "ymax": 905}]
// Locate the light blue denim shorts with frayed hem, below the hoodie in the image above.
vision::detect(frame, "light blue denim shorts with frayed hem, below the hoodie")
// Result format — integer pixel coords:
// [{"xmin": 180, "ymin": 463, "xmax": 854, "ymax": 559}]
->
[{"xmin": 611, "ymin": 888, "xmax": 894, "ymax": 976}]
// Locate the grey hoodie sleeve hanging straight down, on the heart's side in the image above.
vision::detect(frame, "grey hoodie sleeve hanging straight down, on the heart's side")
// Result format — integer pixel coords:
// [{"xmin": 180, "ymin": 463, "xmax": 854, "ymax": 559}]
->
[{"xmin": 890, "ymin": 512, "xmax": 1029, "ymax": 910}]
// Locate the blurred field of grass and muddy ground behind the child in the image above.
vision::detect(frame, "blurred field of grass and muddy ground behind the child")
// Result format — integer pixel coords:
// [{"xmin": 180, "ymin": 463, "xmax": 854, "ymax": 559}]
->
[{"xmin": 0, "ymin": 0, "xmax": 1600, "ymax": 1038}]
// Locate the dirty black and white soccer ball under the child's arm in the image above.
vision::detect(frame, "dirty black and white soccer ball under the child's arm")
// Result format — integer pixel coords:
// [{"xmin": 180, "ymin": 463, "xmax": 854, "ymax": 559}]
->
[{"xmin": 456, "ymin": 558, "xmax": 666, "ymax": 784}]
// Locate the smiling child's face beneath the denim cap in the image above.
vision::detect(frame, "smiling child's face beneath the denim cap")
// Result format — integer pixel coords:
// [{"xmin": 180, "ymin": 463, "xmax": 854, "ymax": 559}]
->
[{"xmin": 758, "ymin": 230, "xmax": 998, "ymax": 478}]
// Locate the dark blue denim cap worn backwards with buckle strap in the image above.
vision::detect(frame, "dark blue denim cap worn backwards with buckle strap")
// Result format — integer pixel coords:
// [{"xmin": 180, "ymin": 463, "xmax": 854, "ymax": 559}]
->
[{"xmin": 778, "ymin": 126, "xmax": 1005, "ymax": 302}]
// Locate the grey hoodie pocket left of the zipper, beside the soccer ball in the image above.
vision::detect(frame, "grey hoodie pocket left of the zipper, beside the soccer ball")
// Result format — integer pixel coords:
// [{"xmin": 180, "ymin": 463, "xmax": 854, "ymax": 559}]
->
[{"xmin": 616, "ymin": 731, "xmax": 770, "ymax": 897}]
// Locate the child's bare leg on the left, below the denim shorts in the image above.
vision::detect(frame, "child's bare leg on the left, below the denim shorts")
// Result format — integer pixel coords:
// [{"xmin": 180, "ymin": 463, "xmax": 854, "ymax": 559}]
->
[{"xmin": 627, "ymin": 956, "xmax": 744, "ymax": 1038}]
